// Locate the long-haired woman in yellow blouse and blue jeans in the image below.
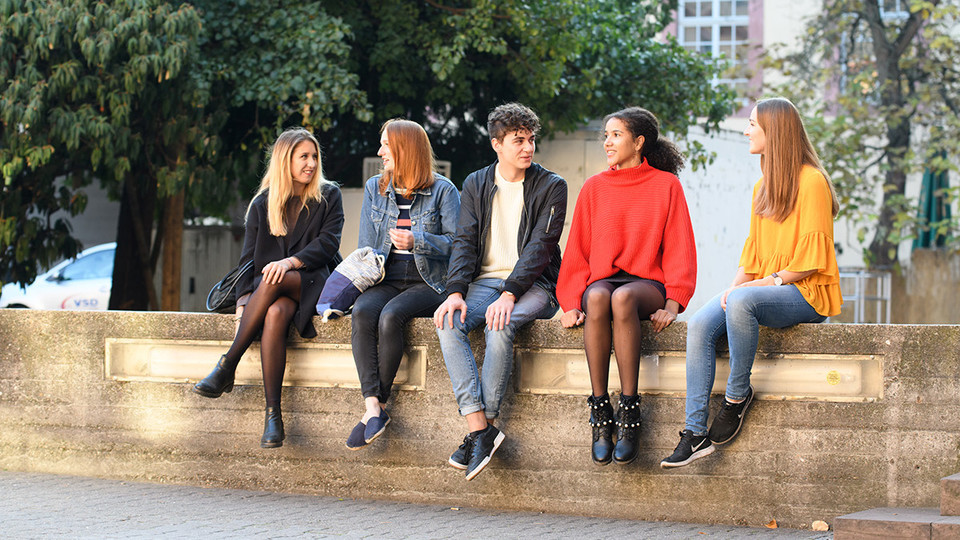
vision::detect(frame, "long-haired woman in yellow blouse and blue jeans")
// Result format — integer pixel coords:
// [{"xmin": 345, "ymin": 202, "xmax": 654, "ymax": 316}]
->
[{"xmin": 660, "ymin": 98, "xmax": 843, "ymax": 467}]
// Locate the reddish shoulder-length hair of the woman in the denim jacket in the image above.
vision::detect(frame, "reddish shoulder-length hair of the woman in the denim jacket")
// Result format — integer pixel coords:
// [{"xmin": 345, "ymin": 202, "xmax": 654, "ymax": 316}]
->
[{"xmin": 379, "ymin": 118, "xmax": 436, "ymax": 198}]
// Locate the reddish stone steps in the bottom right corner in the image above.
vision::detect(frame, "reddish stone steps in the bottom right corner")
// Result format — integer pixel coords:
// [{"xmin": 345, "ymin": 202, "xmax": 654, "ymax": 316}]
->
[{"xmin": 833, "ymin": 474, "xmax": 960, "ymax": 540}]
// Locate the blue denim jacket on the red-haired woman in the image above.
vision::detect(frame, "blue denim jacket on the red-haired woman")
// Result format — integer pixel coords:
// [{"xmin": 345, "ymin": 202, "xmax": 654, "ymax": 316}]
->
[{"xmin": 357, "ymin": 173, "xmax": 460, "ymax": 293}]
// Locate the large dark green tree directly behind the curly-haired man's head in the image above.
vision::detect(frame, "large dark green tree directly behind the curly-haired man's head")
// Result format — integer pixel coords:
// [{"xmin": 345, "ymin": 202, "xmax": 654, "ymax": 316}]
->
[{"xmin": 322, "ymin": 0, "xmax": 733, "ymax": 185}]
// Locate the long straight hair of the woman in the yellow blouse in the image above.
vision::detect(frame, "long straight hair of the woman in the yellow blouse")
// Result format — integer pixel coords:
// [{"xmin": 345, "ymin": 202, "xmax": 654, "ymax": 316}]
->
[{"xmin": 753, "ymin": 97, "xmax": 840, "ymax": 223}]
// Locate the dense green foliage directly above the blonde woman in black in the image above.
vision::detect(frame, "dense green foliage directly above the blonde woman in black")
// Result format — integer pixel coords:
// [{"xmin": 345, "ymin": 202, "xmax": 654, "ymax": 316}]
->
[{"xmin": 192, "ymin": 0, "xmax": 372, "ymax": 200}]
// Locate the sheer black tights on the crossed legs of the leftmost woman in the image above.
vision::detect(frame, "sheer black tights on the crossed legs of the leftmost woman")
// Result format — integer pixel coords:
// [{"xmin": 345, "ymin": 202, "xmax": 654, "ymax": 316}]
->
[{"xmin": 226, "ymin": 271, "xmax": 300, "ymax": 407}]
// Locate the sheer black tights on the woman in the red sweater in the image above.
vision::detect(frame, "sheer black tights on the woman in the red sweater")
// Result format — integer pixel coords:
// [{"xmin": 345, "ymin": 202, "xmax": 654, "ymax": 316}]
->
[{"xmin": 582, "ymin": 280, "xmax": 665, "ymax": 396}]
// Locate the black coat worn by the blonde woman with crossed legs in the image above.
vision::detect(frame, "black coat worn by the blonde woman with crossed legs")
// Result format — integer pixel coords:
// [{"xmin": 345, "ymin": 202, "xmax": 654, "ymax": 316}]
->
[{"xmin": 237, "ymin": 184, "xmax": 343, "ymax": 338}]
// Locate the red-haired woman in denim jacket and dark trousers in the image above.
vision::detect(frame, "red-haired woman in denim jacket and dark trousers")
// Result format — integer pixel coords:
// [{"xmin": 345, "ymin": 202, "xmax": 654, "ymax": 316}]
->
[{"xmin": 347, "ymin": 120, "xmax": 460, "ymax": 450}]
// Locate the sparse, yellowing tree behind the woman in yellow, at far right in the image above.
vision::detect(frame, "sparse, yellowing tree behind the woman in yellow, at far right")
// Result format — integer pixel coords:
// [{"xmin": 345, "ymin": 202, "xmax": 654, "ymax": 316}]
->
[{"xmin": 774, "ymin": 0, "xmax": 960, "ymax": 267}]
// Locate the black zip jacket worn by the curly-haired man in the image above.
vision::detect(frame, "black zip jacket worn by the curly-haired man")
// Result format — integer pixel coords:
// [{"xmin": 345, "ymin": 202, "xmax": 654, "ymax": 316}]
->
[{"xmin": 446, "ymin": 162, "xmax": 567, "ymax": 298}]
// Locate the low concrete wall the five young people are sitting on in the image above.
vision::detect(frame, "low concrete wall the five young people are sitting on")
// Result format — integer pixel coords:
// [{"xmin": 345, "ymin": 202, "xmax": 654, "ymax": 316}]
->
[{"xmin": 0, "ymin": 310, "xmax": 960, "ymax": 534}]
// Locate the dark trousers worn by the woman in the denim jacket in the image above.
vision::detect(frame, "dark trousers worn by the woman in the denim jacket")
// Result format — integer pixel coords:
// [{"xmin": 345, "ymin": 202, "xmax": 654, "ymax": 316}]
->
[{"xmin": 350, "ymin": 261, "xmax": 445, "ymax": 403}]
